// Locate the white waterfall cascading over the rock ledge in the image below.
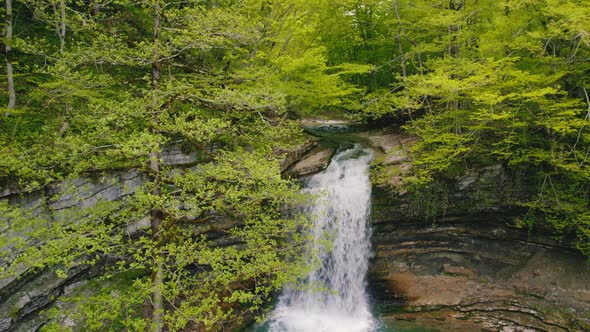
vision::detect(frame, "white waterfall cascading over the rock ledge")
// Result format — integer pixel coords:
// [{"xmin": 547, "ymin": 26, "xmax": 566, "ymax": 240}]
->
[{"xmin": 269, "ymin": 144, "xmax": 376, "ymax": 332}]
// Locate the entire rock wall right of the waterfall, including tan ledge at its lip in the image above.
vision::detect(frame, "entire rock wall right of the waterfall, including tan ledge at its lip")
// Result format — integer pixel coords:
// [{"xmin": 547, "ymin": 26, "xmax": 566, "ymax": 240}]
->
[{"xmin": 369, "ymin": 132, "xmax": 590, "ymax": 331}]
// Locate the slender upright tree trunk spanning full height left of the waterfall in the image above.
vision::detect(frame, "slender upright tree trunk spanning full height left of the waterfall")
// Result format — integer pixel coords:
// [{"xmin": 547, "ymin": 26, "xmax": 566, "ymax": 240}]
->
[{"xmin": 150, "ymin": 1, "xmax": 164, "ymax": 332}]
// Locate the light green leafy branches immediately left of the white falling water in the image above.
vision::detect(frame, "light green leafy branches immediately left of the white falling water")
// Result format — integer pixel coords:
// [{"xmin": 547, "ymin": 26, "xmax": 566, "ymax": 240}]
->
[{"xmin": 29, "ymin": 152, "xmax": 314, "ymax": 331}]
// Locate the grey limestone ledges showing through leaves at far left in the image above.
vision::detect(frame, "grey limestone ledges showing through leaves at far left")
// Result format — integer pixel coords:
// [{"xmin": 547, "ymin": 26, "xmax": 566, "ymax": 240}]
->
[{"xmin": 0, "ymin": 146, "xmax": 221, "ymax": 332}]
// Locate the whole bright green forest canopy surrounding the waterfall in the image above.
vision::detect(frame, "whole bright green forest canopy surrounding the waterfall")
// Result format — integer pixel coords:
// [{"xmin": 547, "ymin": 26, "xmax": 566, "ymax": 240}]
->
[{"xmin": 0, "ymin": 0, "xmax": 590, "ymax": 331}]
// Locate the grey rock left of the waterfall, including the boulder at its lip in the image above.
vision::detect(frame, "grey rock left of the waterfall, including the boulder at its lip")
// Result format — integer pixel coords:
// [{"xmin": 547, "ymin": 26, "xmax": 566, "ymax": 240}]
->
[{"xmin": 0, "ymin": 138, "xmax": 333, "ymax": 332}]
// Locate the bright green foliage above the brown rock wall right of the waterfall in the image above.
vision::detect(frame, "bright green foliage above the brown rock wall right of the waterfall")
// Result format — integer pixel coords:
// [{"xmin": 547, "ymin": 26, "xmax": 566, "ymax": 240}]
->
[{"xmin": 350, "ymin": 1, "xmax": 590, "ymax": 253}]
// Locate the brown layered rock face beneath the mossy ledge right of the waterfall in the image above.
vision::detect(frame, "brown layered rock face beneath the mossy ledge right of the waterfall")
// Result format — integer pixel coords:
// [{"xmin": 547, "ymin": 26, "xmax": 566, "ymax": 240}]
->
[{"xmin": 369, "ymin": 213, "xmax": 590, "ymax": 331}]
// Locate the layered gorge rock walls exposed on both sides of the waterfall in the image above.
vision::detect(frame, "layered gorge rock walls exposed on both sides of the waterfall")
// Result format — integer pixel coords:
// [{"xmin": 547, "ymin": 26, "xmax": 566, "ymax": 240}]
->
[{"xmin": 0, "ymin": 126, "xmax": 590, "ymax": 331}]
